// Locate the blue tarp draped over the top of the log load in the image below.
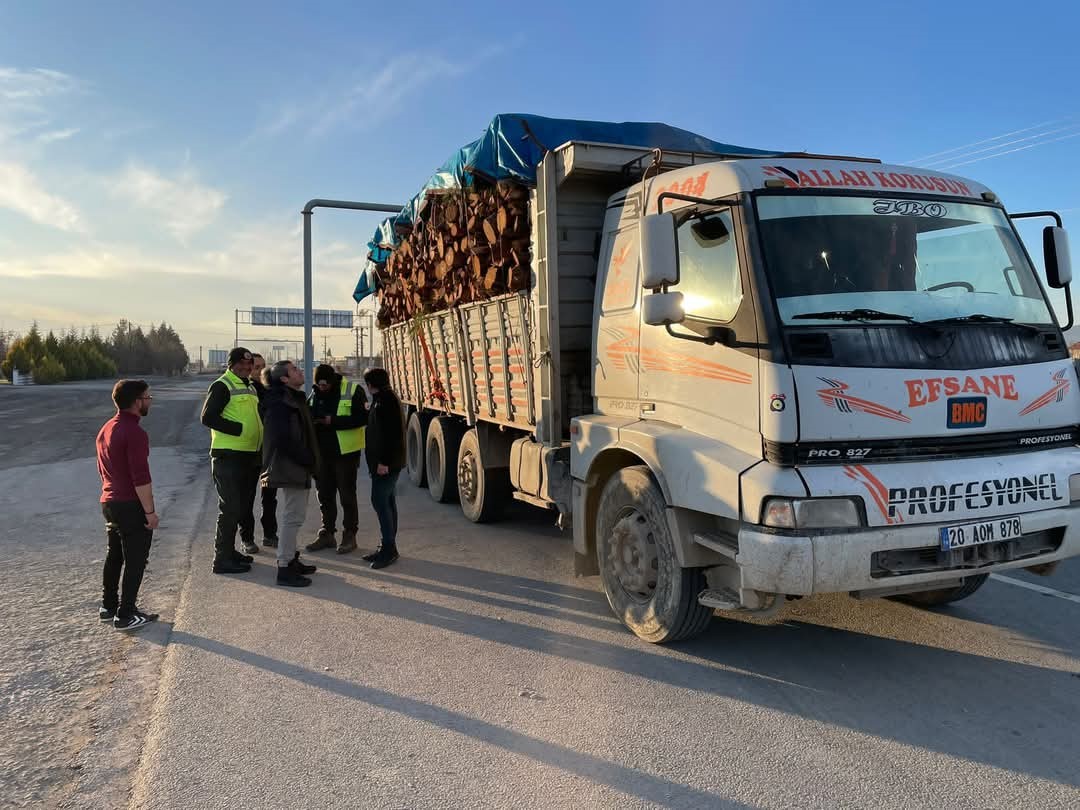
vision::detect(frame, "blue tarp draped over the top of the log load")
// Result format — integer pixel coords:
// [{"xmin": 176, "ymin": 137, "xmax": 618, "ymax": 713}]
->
[{"xmin": 352, "ymin": 113, "xmax": 777, "ymax": 301}]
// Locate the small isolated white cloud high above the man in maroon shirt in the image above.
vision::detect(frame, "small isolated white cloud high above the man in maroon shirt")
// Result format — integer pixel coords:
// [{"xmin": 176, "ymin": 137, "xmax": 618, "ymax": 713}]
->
[{"xmin": 107, "ymin": 163, "xmax": 228, "ymax": 242}]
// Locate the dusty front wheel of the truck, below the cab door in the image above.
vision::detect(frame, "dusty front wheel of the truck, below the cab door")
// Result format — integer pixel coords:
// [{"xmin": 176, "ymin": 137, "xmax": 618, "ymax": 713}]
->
[{"xmin": 596, "ymin": 467, "xmax": 713, "ymax": 644}]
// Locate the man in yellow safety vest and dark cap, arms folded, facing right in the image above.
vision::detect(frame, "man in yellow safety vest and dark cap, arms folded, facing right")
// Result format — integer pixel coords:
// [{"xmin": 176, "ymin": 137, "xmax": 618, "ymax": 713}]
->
[{"xmin": 202, "ymin": 347, "xmax": 262, "ymax": 573}]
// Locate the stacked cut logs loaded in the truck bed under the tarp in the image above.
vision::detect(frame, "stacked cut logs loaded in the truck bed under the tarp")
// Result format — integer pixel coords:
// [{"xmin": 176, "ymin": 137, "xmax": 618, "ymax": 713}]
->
[{"xmin": 378, "ymin": 183, "xmax": 530, "ymax": 327}]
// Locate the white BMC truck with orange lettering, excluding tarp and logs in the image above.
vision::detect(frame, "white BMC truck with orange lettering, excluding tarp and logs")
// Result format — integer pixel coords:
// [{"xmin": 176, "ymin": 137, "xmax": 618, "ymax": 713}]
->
[{"xmin": 383, "ymin": 143, "xmax": 1080, "ymax": 643}]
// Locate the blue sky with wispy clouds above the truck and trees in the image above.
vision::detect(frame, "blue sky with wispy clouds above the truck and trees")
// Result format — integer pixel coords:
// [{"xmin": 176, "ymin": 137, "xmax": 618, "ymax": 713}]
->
[{"xmin": 0, "ymin": 0, "xmax": 1080, "ymax": 356}]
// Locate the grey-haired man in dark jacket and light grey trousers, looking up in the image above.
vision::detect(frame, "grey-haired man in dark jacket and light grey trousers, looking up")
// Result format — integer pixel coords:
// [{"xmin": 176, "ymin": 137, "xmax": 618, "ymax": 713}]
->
[{"xmin": 259, "ymin": 360, "xmax": 319, "ymax": 588}]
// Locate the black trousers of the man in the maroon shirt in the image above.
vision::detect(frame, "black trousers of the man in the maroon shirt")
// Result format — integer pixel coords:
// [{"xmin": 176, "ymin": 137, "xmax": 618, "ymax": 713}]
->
[{"xmin": 102, "ymin": 501, "xmax": 153, "ymax": 619}]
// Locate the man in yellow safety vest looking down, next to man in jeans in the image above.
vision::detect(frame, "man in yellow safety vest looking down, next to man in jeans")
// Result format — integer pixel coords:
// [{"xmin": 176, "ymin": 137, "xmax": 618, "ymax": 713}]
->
[{"xmin": 307, "ymin": 363, "xmax": 367, "ymax": 554}]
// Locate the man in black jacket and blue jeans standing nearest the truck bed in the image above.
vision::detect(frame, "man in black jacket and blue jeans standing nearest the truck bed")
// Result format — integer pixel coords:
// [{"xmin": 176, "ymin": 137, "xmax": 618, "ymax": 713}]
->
[{"xmin": 364, "ymin": 368, "xmax": 405, "ymax": 569}]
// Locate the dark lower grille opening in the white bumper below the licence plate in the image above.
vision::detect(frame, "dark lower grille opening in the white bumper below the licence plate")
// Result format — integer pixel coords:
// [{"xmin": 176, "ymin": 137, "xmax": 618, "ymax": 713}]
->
[{"xmin": 870, "ymin": 527, "xmax": 1065, "ymax": 579}]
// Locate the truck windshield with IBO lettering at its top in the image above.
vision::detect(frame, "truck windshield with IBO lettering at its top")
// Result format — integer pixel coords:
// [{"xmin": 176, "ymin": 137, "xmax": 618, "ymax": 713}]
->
[{"xmin": 757, "ymin": 194, "xmax": 1053, "ymax": 325}]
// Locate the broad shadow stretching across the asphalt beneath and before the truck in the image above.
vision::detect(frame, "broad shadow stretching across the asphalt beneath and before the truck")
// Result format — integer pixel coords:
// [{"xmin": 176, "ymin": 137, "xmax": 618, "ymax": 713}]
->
[{"xmin": 230, "ymin": 557, "xmax": 1080, "ymax": 786}]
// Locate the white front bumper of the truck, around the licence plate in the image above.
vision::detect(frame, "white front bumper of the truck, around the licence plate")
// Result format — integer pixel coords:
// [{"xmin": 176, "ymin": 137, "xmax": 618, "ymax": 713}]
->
[{"xmin": 735, "ymin": 503, "xmax": 1080, "ymax": 596}]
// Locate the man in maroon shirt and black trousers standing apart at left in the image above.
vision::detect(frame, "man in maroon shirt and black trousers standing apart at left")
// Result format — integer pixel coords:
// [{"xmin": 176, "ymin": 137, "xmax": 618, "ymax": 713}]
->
[{"xmin": 97, "ymin": 380, "xmax": 158, "ymax": 630}]
